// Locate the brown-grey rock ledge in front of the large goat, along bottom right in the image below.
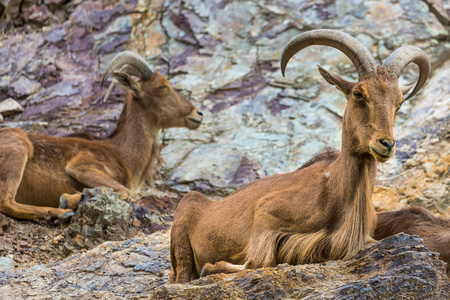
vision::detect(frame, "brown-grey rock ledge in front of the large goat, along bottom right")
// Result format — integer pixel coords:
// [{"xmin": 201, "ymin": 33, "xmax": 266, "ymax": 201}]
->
[{"xmin": 155, "ymin": 234, "xmax": 450, "ymax": 299}]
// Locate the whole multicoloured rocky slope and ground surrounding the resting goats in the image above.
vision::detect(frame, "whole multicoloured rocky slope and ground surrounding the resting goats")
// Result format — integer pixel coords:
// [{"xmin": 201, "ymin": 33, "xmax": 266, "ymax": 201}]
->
[{"xmin": 0, "ymin": 0, "xmax": 450, "ymax": 299}]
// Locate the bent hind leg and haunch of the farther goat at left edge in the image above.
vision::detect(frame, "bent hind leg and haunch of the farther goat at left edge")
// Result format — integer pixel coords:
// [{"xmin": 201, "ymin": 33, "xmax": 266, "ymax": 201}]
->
[{"xmin": 0, "ymin": 128, "xmax": 73, "ymax": 221}]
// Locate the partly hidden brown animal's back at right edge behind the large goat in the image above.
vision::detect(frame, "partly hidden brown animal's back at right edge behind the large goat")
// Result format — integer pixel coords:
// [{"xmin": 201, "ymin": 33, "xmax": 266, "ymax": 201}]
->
[{"xmin": 375, "ymin": 206, "xmax": 450, "ymax": 278}]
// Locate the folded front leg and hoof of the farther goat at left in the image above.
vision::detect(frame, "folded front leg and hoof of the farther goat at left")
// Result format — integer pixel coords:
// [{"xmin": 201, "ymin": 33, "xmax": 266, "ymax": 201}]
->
[{"xmin": 60, "ymin": 153, "xmax": 130, "ymax": 210}]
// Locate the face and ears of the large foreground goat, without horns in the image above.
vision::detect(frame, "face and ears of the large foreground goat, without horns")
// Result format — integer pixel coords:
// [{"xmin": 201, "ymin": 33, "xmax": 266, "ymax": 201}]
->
[{"xmin": 319, "ymin": 67, "xmax": 409, "ymax": 162}]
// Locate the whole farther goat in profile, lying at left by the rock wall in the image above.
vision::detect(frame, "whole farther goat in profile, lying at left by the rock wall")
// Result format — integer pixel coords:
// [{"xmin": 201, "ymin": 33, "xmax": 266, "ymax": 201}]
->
[{"xmin": 0, "ymin": 51, "xmax": 203, "ymax": 220}]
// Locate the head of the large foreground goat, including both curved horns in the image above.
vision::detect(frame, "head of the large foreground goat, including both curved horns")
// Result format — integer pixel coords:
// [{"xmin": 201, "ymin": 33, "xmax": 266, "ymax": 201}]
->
[{"xmin": 281, "ymin": 29, "xmax": 430, "ymax": 162}]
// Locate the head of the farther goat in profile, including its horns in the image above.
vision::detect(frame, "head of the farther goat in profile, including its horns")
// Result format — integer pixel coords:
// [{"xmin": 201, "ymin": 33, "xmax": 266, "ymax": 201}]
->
[{"xmin": 102, "ymin": 51, "xmax": 203, "ymax": 129}]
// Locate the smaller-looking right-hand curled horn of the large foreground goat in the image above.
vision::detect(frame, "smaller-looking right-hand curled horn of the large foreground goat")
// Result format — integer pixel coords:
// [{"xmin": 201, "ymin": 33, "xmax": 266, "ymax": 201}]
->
[{"xmin": 383, "ymin": 46, "xmax": 431, "ymax": 100}]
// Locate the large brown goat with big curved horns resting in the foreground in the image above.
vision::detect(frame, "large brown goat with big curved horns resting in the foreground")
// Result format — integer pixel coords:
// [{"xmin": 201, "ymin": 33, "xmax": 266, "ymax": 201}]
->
[{"xmin": 169, "ymin": 30, "xmax": 430, "ymax": 283}]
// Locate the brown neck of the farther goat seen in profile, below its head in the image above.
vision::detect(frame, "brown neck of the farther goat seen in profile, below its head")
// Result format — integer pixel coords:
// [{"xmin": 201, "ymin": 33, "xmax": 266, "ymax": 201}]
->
[{"xmin": 103, "ymin": 93, "xmax": 160, "ymax": 190}]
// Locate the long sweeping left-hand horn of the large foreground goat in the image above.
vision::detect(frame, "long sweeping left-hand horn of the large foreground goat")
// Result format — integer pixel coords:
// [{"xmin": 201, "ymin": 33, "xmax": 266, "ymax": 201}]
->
[{"xmin": 280, "ymin": 29, "xmax": 377, "ymax": 77}]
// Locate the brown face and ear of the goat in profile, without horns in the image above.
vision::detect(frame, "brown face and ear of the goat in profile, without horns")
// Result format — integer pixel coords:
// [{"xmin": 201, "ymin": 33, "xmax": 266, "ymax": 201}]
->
[{"xmin": 113, "ymin": 72, "xmax": 203, "ymax": 129}]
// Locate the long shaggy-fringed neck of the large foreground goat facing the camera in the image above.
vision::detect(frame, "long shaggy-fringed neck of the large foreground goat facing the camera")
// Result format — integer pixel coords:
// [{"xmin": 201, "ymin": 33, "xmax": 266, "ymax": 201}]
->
[{"xmin": 328, "ymin": 140, "xmax": 377, "ymax": 259}]
